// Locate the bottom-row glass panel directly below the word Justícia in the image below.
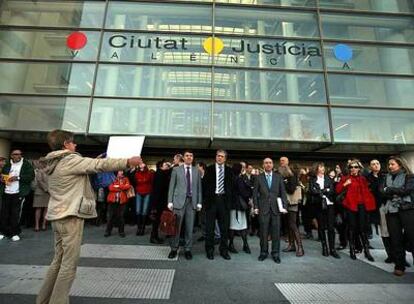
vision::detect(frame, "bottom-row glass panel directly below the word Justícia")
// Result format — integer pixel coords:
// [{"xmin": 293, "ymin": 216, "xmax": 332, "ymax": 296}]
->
[{"xmin": 214, "ymin": 103, "xmax": 330, "ymax": 141}]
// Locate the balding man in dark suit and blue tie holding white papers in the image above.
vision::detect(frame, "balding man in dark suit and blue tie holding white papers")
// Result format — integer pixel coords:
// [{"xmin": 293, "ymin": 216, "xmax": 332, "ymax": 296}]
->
[{"xmin": 253, "ymin": 158, "xmax": 287, "ymax": 264}]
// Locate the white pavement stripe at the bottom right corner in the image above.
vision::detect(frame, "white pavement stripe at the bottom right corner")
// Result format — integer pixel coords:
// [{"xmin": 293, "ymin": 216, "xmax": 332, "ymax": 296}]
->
[{"xmin": 275, "ymin": 283, "xmax": 414, "ymax": 304}]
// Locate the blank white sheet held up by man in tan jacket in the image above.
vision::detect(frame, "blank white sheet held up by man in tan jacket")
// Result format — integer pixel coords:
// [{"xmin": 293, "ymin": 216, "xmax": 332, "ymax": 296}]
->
[{"xmin": 106, "ymin": 136, "xmax": 145, "ymax": 158}]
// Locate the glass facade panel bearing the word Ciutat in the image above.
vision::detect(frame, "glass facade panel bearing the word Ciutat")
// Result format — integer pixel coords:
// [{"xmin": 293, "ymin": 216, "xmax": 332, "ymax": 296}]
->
[{"xmin": 100, "ymin": 32, "xmax": 212, "ymax": 64}]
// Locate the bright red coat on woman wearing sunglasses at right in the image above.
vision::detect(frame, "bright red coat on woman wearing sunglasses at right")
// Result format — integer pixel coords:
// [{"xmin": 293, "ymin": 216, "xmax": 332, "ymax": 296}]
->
[{"xmin": 335, "ymin": 175, "xmax": 375, "ymax": 212}]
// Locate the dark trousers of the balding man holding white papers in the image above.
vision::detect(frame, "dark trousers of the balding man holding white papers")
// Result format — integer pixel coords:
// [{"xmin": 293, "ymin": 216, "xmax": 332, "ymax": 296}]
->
[{"xmin": 259, "ymin": 211, "xmax": 280, "ymax": 257}]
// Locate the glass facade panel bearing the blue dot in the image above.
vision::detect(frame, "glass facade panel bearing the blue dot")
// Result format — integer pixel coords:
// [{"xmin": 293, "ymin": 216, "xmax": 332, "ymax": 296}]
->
[{"xmin": 325, "ymin": 43, "xmax": 414, "ymax": 74}]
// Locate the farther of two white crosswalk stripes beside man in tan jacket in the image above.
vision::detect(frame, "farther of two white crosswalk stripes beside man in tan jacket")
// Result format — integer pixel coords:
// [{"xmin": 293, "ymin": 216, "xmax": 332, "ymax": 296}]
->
[{"xmin": 81, "ymin": 244, "xmax": 178, "ymax": 261}]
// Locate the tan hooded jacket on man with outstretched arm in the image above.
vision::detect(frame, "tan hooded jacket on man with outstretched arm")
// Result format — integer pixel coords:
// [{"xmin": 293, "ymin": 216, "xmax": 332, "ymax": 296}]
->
[{"xmin": 42, "ymin": 150, "xmax": 127, "ymax": 221}]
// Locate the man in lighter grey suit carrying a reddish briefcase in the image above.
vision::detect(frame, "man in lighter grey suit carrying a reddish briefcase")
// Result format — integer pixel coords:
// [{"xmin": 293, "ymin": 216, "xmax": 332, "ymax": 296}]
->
[{"xmin": 168, "ymin": 151, "xmax": 202, "ymax": 260}]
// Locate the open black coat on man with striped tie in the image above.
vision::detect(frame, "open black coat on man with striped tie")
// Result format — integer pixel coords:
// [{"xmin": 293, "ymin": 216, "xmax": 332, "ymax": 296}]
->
[{"xmin": 202, "ymin": 164, "xmax": 234, "ymax": 210}]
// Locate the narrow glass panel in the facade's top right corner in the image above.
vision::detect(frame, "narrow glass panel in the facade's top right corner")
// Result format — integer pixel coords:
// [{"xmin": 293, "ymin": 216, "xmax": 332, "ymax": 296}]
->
[{"xmin": 319, "ymin": 0, "xmax": 414, "ymax": 13}]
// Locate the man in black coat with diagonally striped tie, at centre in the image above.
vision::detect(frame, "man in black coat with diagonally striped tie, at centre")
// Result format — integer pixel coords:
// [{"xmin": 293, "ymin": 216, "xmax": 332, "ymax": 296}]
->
[{"xmin": 203, "ymin": 150, "xmax": 233, "ymax": 260}]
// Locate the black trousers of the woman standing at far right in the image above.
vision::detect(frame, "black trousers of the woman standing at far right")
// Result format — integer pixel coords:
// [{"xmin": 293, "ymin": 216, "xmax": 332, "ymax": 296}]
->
[{"xmin": 386, "ymin": 209, "xmax": 414, "ymax": 271}]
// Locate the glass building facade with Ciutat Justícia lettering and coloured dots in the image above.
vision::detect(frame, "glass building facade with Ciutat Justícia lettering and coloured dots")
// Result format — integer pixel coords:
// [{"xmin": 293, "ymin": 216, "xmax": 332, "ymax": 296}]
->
[{"xmin": 0, "ymin": 0, "xmax": 414, "ymax": 153}]
